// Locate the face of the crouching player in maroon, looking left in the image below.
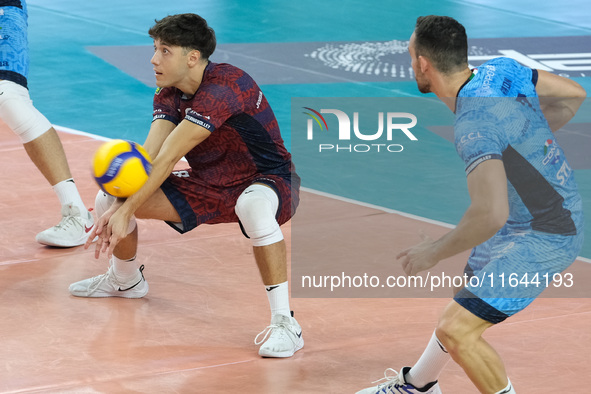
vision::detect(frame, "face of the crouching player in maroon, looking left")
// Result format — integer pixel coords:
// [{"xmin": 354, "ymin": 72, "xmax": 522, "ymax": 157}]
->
[{"xmin": 150, "ymin": 38, "xmax": 189, "ymax": 88}]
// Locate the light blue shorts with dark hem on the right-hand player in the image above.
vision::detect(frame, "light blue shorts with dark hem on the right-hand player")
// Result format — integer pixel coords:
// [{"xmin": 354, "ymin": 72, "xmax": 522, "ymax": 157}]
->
[{"xmin": 454, "ymin": 229, "xmax": 583, "ymax": 324}]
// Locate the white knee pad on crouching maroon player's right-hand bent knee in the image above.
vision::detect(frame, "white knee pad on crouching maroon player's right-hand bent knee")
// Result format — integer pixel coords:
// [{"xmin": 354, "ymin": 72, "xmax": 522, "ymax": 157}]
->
[{"xmin": 234, "ymin": 184, "xmax": 283, "ymax": 246}]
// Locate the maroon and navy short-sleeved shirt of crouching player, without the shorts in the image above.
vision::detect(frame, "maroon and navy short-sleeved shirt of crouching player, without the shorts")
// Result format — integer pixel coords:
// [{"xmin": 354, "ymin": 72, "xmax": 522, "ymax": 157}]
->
[{"xmin": 154, "ymin": 62, "xmax": 299, "ymax": 188}]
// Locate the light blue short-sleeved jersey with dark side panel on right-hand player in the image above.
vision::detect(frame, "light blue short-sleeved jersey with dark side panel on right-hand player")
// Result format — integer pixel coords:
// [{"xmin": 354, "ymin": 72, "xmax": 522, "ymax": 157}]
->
[{"xmin": 455, "ymin": 58, "xmax": 583, "ymax": 235}]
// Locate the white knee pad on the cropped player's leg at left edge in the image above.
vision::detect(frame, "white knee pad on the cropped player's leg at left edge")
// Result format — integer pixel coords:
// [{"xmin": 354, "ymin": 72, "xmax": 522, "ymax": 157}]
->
[{"xmin": 0, "ymin": 81, "xmax": 52, "ymax": 144}]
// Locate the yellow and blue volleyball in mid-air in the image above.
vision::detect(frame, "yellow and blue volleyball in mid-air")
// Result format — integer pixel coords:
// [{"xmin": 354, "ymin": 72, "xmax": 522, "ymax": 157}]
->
[{"xmin": 92, "ymin": 140, "xmax": 152, "ymax": 197}]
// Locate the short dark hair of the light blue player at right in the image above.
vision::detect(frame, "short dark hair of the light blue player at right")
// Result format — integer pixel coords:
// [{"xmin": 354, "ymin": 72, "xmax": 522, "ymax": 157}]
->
[{"xmin": 414, "ymin": 15, "xmax": 468, "ymax": 74}]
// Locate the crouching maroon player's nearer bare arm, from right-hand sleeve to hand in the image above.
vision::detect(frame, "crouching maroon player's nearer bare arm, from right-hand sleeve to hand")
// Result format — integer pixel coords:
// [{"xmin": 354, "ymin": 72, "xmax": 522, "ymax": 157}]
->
[{"xmin": 102, "ymin": 120, "xmax": 211, "ymax": 257}]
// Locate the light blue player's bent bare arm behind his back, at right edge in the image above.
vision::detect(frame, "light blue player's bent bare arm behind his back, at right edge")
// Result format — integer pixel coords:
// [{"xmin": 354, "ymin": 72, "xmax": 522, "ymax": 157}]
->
[{"xmin": 536, "ymin": 70, "xmax": 587, "ymax": 131}]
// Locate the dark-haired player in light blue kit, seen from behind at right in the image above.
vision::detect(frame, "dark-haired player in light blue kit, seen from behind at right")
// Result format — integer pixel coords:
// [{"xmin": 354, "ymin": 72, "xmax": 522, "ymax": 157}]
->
[{"xmin": 360, "ymin": 15, "xmax": 586, "ymax": 394}]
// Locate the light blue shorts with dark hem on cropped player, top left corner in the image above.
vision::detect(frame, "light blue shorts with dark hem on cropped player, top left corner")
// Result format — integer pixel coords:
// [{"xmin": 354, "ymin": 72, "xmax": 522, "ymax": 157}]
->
[{"xmin": 0, "ymin": 0, "xmax": 29, "ymax": 88}]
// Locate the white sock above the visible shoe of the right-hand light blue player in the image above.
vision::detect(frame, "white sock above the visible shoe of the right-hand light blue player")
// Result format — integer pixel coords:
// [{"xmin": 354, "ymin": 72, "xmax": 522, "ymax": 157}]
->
[{"xmin": 405, "ymin": 331, "xmax": 451, "ymax": 388}]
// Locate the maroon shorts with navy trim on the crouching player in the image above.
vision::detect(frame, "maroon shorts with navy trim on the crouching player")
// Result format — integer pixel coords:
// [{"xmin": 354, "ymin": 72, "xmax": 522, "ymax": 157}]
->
[{"xmin": 160, "ymin": 169, "xmax": 300, "ymax": 234}]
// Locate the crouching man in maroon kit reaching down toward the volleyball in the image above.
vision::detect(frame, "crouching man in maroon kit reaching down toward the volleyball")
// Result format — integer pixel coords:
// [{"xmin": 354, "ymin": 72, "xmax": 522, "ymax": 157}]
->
[{"xmin": 70, "ymin": 14, "xmax": 304, "ymax": 357}]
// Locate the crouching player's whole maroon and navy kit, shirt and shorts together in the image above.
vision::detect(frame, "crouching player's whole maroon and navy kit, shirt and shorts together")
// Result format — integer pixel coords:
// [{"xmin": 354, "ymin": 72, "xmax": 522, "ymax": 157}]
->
[{"xmin": 154, "ymin": 63, "xmax": 300, "ymax": 232}]
